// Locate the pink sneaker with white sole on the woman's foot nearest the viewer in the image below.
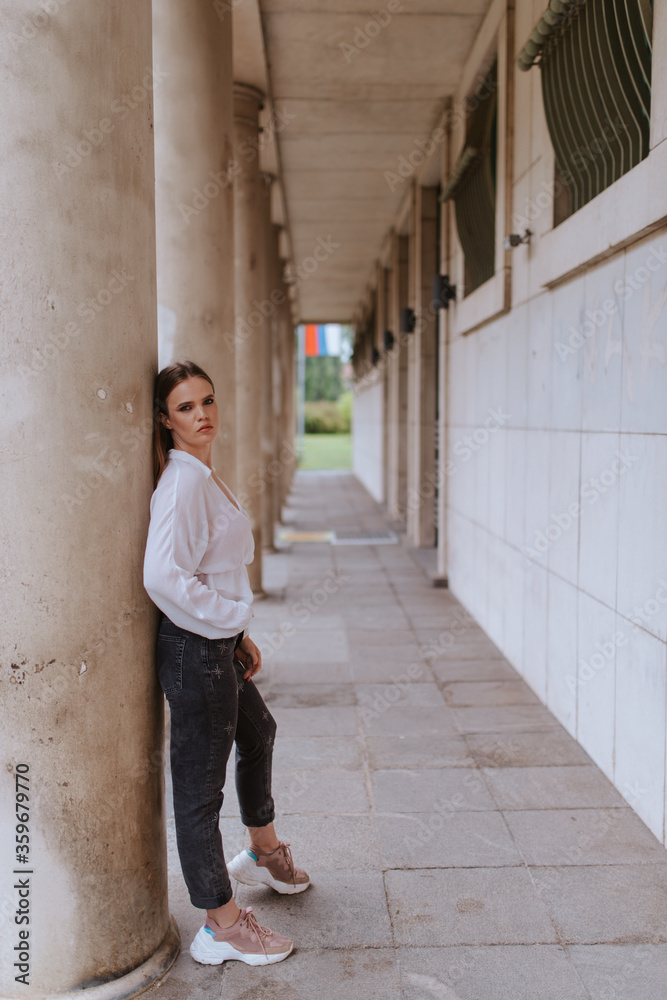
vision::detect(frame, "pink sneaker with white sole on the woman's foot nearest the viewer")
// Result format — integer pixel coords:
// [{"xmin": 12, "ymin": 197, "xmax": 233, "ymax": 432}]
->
[{"xmin": 190, "ymin": 906, "xmax": 294, "ymax": 965}]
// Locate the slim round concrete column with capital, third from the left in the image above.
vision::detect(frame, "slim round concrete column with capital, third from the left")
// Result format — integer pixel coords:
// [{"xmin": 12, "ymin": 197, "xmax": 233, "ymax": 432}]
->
[{"xmin": 234, "ymin": 83, "xmax": 264, "ymax": 596}]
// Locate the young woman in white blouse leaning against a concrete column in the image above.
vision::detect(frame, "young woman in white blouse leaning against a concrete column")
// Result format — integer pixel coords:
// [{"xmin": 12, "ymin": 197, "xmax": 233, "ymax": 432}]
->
[{"xmin": 144, "ymin": 361, "xmax": 310, "ymax": 965}]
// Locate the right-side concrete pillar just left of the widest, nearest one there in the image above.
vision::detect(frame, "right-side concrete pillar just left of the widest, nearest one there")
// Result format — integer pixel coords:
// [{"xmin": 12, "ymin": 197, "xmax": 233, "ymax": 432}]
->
[{"xmin": 387, "ymin": 234, "xmax": 409, "ymax": 523}]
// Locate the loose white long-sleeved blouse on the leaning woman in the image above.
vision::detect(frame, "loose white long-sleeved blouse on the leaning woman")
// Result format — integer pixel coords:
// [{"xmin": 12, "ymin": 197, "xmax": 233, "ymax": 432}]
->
[{"xmin": 144, "ymin": 448, "xmax": 255, "ymax": 639}]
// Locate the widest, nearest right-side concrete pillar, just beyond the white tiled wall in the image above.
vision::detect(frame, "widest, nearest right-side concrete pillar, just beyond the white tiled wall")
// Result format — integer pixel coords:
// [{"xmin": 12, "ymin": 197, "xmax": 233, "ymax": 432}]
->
[{"xmin": 408, "ymin": 185, "xmax": 439, "ymax": 548}]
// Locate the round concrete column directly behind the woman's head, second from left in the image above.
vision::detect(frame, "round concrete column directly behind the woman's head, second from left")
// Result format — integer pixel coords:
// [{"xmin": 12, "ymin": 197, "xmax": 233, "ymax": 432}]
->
[{"xmin": 153, "ymin": 0, "xmax": 237, "ymax": 490}]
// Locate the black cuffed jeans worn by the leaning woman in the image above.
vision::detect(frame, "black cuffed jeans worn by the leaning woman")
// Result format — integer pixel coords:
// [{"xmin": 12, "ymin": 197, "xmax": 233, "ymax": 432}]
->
[{"xmin": 157, "ymin": 614, "xmax": 276, "ymax": 910}]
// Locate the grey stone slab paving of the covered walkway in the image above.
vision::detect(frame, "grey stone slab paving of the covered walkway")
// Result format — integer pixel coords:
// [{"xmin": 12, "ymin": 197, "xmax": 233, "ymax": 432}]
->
[{"xmin": 146, "ymin": 472, "xmax": 667, "ymax": 1000}]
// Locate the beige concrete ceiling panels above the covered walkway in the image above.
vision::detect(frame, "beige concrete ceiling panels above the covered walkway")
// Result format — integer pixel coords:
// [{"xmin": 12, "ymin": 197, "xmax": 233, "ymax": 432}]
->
[{"xmin": 235, "ymin": 0, "xmax": 490, "ymax": 322}]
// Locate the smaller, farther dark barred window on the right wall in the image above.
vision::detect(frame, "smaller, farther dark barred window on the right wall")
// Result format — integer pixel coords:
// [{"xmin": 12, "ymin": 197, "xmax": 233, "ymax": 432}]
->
[{"xmin": 440, "ymin": 60, "xmax": 498, "ymax": 295}]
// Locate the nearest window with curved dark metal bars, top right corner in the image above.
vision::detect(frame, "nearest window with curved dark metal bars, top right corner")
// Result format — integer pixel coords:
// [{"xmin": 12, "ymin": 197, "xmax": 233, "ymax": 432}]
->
[{"xmin": 519, "ymin": 0, "xmax": 653, "ymax": 226}]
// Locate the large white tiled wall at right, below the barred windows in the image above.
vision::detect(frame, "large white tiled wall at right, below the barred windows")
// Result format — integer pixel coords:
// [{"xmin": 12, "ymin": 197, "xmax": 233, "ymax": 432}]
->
[{"xmin": 448, "ymin": 232, "xmax": 667, "ymax": 841}]
